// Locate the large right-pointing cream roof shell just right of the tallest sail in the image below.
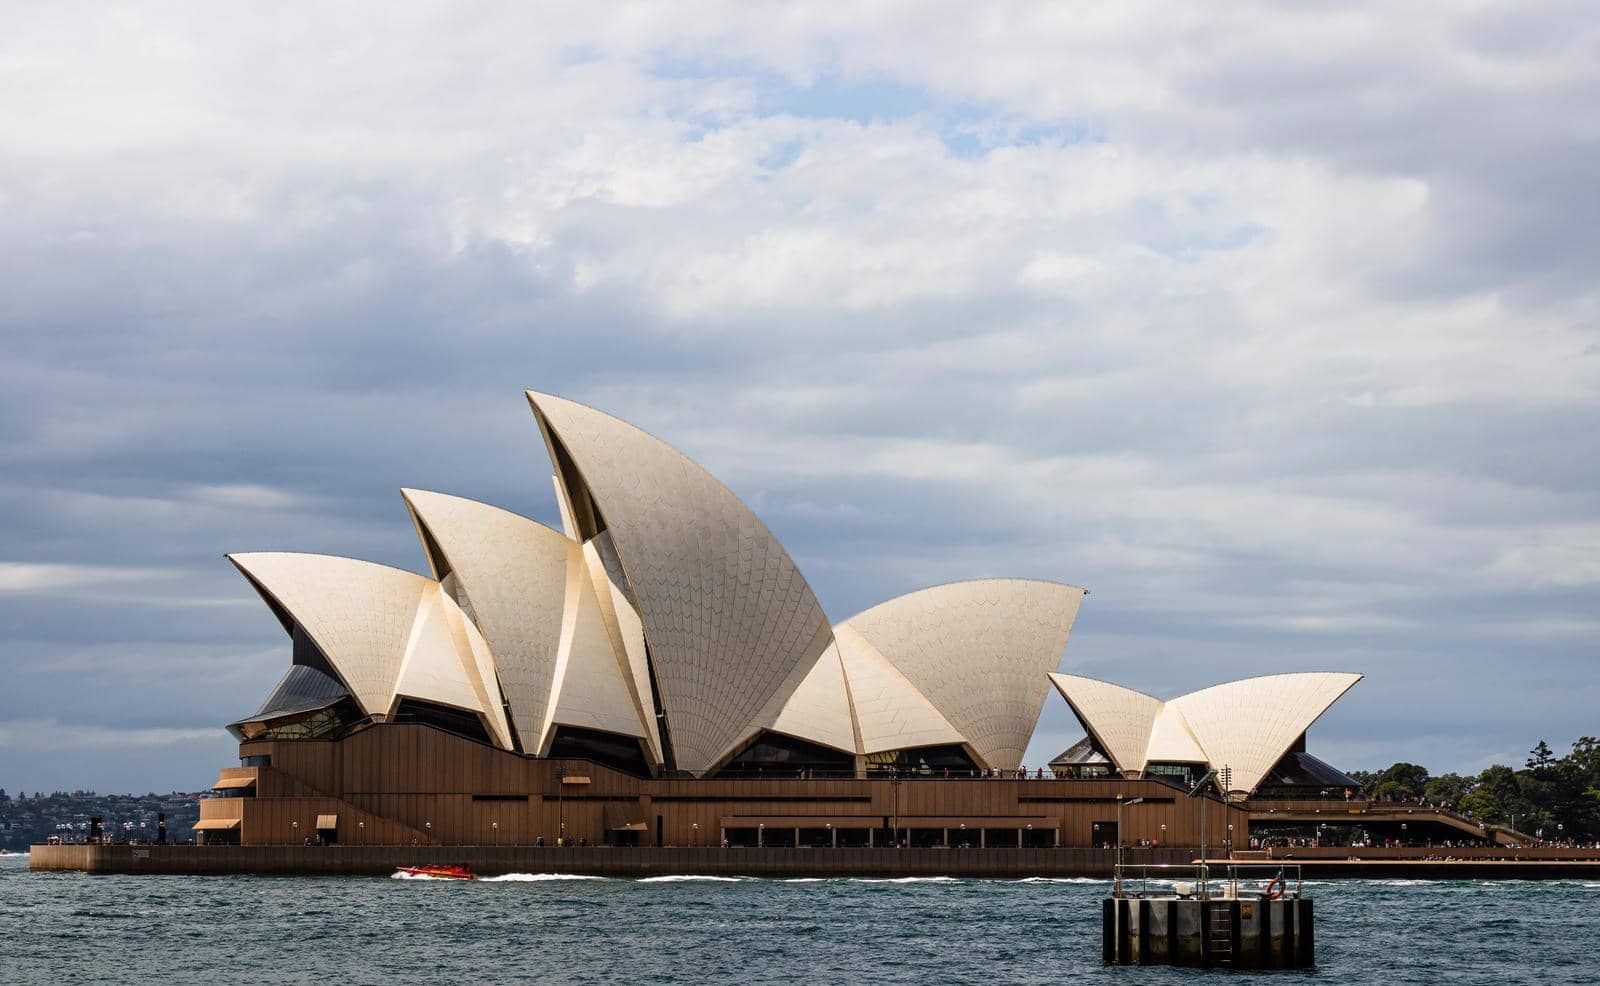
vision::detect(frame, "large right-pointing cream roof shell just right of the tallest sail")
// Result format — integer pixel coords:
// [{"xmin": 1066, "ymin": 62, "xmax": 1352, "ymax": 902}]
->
[{"xmin": 842, "ymin": 579, "xmax": 1083, "ymax": 770}]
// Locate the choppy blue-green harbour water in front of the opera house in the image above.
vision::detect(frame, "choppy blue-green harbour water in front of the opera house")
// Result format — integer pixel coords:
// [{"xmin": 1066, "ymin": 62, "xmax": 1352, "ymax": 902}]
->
[{"xmin": 0, "ymin": 856, "xmax": 1600, "ymax": 986}]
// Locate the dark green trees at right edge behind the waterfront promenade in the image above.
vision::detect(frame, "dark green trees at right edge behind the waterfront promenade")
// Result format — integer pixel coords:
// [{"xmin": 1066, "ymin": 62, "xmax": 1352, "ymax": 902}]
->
[{"xmin": 1350, "ymin": 736, "xmax": 1600, "ymax": 842}]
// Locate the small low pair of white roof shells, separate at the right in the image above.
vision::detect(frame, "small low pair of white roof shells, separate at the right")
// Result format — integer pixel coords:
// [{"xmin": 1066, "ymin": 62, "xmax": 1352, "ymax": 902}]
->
[{"xmin": 1050, "ymin": 671, "xmax": 1362, "ymax": 792}]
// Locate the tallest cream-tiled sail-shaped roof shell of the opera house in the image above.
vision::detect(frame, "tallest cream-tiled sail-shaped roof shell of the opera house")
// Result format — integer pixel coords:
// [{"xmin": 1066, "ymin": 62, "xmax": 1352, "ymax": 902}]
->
[{"xmin": 528, "ymin": 392, "xmax": 832, "ymax": 773}]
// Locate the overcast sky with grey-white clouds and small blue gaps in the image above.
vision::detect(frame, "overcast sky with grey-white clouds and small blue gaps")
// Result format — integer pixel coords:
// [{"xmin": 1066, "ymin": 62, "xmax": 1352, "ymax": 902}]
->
[{"xmin": 0, "ymin": 3, "xmax": 1600, "ymax": 792}]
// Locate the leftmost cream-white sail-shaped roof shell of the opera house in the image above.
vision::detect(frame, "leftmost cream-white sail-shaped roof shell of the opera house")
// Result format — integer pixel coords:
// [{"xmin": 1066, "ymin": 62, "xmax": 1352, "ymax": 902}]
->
[{"xmin": 229, "ymin": 552, "xmax": 510, "ymax": 746}]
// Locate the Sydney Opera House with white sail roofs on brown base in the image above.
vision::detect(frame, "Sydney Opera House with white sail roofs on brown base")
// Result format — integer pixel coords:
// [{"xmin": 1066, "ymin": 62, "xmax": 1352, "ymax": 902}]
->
[{"xmin": 197, "ymin": 392, "xmax": 1358, "ymax": 847}]
